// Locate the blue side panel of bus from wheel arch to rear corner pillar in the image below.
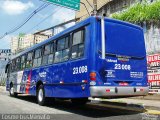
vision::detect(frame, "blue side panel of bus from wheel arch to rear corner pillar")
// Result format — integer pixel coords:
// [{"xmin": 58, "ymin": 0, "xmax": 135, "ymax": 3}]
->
[{"xmin": 26, "ymin": 22, "xmax": 90, "ymax": 98}]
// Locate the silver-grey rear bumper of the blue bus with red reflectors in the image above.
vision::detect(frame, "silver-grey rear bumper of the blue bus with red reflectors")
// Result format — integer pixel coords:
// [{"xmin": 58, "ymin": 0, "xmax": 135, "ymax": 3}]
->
[{"xmin": 90, "ymin": 86, "xmax": 149, "ymax": 97}]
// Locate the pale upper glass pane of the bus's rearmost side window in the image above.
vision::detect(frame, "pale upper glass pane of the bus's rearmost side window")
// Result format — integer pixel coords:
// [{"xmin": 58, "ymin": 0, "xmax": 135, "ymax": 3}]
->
[{"xmin": 72, "ymin": 31, "xmax": 83, "ymax": 45}]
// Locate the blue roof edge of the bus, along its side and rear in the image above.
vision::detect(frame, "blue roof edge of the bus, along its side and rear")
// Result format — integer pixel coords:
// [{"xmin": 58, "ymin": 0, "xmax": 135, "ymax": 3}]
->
[{"xmin": 12, "ymin": 16, "xmax": 142, "ymax": 59}]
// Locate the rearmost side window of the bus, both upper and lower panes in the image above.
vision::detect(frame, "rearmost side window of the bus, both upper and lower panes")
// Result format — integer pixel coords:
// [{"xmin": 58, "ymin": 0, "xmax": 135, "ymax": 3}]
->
[{"xmin": 71, "ymin": 30, "xmax": 85, "ymax": 59}]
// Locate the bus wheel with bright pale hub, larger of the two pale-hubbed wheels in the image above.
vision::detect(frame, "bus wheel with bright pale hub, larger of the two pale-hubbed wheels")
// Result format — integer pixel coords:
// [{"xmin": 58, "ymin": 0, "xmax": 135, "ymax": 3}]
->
[{"xmin": 37, "ymin": 85, "xmax": 46, "ymax": 106}]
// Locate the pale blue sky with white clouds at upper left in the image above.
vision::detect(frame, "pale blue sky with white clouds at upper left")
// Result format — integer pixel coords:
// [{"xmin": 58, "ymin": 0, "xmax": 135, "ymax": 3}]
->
[{"xmin": 0, "ymin": 0, "xmax": 75, "ymax": 49}]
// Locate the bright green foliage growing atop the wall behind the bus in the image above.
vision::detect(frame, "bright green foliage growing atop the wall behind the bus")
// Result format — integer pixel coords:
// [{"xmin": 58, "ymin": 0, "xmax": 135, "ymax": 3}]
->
[{"xmin": 111, "ymin": 0, "xmax": 160, "ymax": 23}]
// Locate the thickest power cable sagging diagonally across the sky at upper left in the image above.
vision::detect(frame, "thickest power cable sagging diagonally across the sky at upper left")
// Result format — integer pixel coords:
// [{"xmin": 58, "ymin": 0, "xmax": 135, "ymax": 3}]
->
[{"xmin": 0, "ymin": 3, "xmax": 49, "ymax": 39}]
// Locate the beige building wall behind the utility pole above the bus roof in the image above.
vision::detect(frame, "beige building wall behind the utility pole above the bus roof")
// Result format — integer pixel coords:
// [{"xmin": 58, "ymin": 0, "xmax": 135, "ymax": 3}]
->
[{"xmin": 76, "ymin": 0, "xmax": 137, "ymax": 21}]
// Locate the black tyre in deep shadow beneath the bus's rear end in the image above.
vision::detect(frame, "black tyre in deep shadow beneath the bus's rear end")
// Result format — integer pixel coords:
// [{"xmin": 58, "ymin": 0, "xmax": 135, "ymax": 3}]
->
[{"xmin": 71, "ymin": 98, "xmax": 88, "ymax": 105}]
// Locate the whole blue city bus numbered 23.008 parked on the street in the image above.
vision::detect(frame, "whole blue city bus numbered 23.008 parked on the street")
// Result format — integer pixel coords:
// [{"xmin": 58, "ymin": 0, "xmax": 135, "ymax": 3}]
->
[{"xmin": 6, "ymin": 16, "xmax": 148, "ymax": 105}]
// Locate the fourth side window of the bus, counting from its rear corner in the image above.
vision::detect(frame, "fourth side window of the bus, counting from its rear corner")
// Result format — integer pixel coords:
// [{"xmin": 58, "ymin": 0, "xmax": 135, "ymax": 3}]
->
[{"xmin": 33, "ymin": 48, "xmax": 42, "ymax": 67}]
